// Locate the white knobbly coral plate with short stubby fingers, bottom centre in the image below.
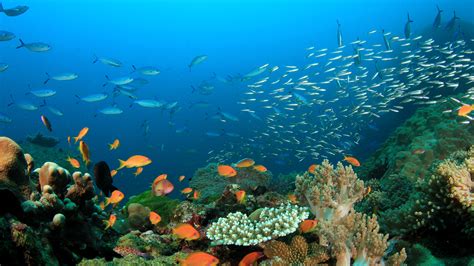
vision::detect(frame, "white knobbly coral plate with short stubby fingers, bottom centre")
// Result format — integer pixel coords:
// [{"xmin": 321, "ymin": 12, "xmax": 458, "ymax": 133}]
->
[{"xmin": 206, "ymin": 204, "xmax": 309, "ymax": 246}]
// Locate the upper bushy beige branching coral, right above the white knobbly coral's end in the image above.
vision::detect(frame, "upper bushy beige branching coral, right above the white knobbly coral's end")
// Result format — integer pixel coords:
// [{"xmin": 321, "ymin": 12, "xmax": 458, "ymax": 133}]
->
[{"xmin": 295, "ymin": 160, "xmax": 365, "ymax": 222}]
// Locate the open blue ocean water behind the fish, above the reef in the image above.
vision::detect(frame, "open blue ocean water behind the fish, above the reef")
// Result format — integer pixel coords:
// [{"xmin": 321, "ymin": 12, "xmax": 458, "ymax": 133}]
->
[{"xmin": 0, "ymin": 0, "xmax": 474, "ymax": 195}]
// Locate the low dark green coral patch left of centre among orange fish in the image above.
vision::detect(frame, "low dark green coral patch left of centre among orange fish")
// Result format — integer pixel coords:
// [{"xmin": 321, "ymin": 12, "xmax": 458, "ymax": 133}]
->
[{"xmin": 126, "ymin": 190, "xmax": 179, "ymax": 224}]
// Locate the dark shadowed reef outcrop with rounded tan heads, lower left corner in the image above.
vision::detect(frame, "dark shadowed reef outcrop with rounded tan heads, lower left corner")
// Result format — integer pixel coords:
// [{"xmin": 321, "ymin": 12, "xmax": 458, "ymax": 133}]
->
[{"xmin": 0, "ymin": 138, "xmax": 118, "ymax": 265}]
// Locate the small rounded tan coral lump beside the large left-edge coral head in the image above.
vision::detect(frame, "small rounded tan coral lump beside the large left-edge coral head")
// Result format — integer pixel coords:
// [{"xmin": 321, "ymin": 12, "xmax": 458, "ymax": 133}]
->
[{"xmin": 39, "ymin": 162, "xmax": 71, "ymax": 195}]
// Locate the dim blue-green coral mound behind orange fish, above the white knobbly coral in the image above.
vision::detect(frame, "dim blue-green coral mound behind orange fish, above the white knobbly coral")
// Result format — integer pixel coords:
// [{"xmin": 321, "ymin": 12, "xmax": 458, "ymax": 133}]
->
[{"xmin": 189, "ymin": 164, "xmax": 272, "ymax": 202}]
